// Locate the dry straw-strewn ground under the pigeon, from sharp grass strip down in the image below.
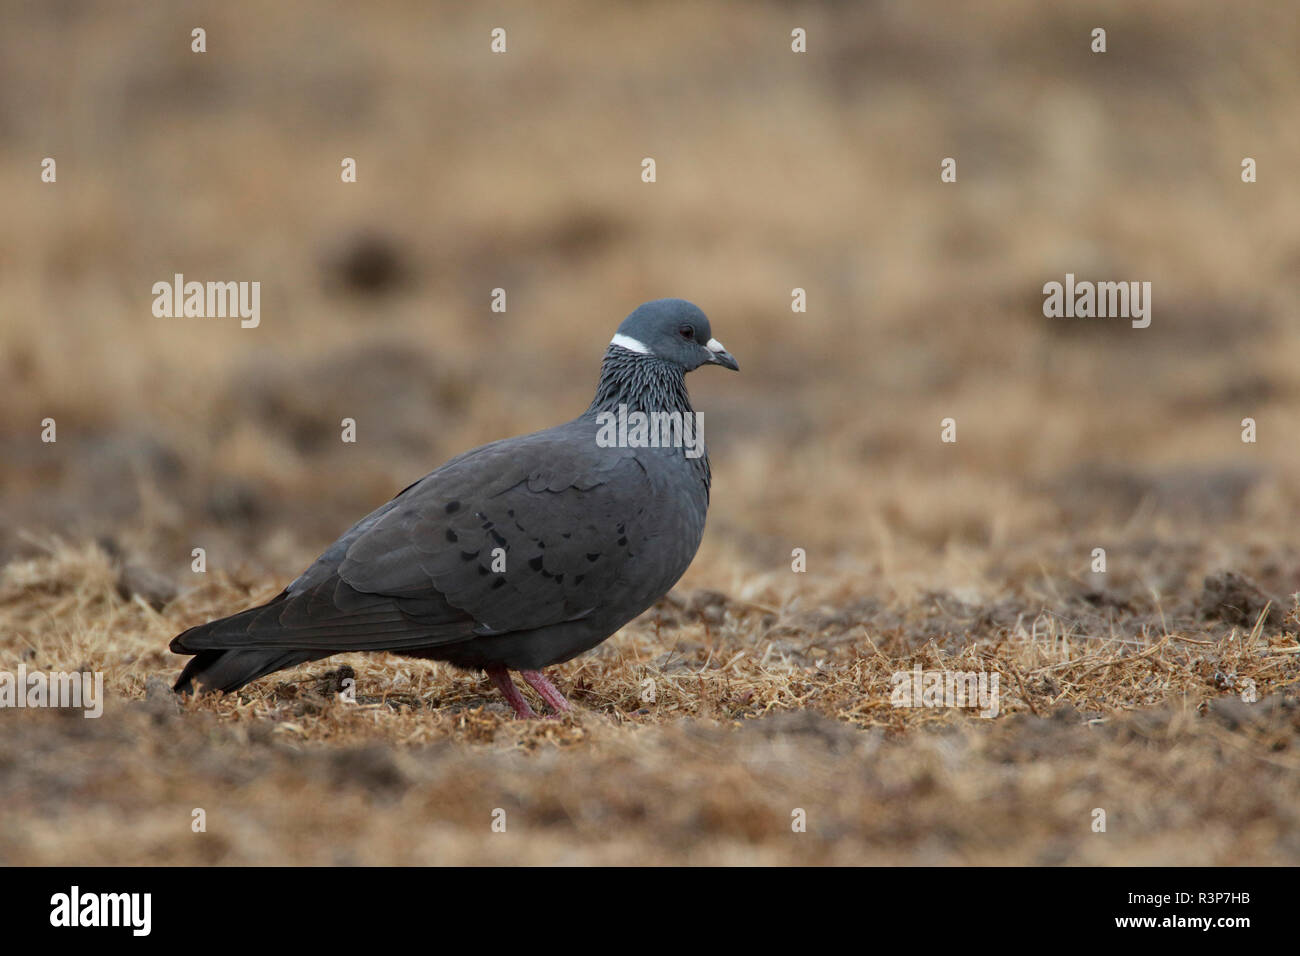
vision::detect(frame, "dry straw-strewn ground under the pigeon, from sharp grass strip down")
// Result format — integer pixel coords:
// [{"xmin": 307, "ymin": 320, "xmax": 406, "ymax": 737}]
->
[{"xmin": 0, "ymin": 538, "xmax": 1300, "ymax": 864}]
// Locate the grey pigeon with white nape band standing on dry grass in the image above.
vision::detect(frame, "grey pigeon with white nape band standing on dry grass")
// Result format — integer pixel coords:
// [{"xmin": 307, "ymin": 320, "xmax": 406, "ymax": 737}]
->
[{"xmin": 170, "ymin": 299, "xmax": 740, "ymax": 718}]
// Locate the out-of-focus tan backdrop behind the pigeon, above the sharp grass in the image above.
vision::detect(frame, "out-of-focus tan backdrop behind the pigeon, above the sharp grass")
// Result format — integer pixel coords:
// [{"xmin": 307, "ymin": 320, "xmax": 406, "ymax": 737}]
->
[{"xmin": 0, "ymin": 1, "xmax": 1300, "ymax": 598}]
